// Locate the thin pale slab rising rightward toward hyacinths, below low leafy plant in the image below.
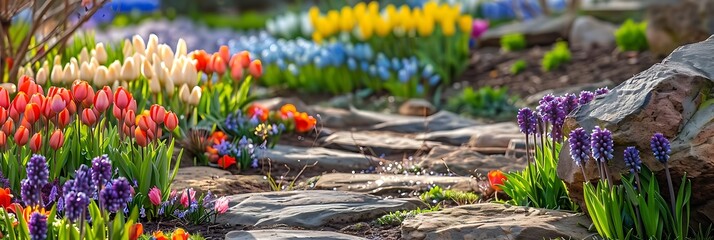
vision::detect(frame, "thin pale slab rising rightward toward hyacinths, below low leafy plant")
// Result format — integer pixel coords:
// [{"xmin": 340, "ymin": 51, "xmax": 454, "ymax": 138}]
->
[{"xmin": 416, "ymin": 122, "xmax": 519, "ymax": 146}]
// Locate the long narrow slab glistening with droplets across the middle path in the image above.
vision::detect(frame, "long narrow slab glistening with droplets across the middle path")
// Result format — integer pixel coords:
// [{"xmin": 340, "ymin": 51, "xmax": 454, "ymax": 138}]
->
[{"xmin": 315, "ymin": 173, "xmax": 479, "ymax": 196}]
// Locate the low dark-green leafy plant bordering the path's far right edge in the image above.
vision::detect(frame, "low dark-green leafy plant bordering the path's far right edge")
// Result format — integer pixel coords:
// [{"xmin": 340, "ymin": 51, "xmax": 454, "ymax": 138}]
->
[{"xmin": 446, "ymin": 86, "xmax": 518, "ymax": 120}]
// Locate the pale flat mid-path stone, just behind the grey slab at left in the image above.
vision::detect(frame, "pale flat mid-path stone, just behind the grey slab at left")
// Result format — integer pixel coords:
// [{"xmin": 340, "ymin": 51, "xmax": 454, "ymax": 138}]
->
[{"xmin": 320, "ymin": 131, "xmax": 441, "ymax": 155}]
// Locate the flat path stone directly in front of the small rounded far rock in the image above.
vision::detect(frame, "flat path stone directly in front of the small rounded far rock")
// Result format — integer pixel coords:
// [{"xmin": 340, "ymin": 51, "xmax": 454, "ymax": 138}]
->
[{"xmin": 370, "ymin": 111, "xmax": 478, "ymax": 133}]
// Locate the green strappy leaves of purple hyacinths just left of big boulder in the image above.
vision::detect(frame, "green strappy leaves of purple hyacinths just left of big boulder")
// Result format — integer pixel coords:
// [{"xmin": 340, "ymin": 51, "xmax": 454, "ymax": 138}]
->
[{"xmin": 501, "ymin": 141, "xmax": 578, "ymax": 210}]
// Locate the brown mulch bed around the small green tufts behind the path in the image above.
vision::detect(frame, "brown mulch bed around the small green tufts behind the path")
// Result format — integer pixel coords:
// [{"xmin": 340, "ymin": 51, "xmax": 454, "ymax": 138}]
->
[{"xmin": 456, "ymin": 46, "xmax": 662, "ymax": 97}]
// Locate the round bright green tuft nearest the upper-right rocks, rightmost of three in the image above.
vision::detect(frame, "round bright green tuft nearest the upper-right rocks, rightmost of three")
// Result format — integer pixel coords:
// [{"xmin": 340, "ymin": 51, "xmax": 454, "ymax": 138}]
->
[{"xmin": 615, "ymin": 19, "xmax": 648, "ymax": 51}]
